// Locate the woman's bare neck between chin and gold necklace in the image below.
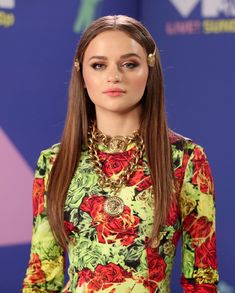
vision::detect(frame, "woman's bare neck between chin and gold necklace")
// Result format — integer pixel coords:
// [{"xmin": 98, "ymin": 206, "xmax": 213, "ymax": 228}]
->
[{"xmin": 96, "ymin": 109, "xmax": 141, "ymax": 137}]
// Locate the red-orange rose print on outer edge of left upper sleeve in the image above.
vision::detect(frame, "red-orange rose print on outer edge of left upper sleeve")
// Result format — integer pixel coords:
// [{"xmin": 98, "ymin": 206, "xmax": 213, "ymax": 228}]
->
[{"xmin": 33, "ymin": 178, "xmax": 45, "ymax": 217}]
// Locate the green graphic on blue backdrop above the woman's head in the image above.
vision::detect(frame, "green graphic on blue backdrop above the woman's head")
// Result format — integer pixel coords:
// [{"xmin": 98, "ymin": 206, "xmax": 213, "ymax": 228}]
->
[{"xmin": 73, "ymin": 0, "xmax": 103, "ymax": 33}]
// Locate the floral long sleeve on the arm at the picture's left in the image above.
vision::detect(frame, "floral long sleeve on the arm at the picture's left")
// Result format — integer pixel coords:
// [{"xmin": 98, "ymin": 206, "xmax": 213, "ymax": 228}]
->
[{"xmin": 22, "ymin": 150, "xmax": 64, "ymax": 293}]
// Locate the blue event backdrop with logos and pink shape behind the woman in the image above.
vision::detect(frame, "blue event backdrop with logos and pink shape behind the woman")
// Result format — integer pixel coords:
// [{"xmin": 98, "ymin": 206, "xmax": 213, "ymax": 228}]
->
[{"xmin": 0, "ymin": 0, "xmax": 235, "ymax": 293}]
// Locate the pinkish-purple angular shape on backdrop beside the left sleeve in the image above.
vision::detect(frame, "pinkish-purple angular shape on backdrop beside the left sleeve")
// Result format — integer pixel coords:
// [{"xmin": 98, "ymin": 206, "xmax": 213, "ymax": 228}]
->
[{"xmin": 0, "ymin": 128, "xmax": 34, "ymax": 246}]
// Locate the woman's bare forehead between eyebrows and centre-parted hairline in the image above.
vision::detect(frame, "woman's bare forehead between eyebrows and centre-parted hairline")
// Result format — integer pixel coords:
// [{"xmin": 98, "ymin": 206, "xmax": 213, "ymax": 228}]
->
[{"xmin": 84, "ymin": 30, "xmax": 146, "ymax": 58}]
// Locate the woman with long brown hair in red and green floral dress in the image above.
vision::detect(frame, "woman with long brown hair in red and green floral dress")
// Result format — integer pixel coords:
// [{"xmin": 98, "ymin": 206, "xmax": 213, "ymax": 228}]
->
[{"xmin": 23, "ymin": 16, "xmax": 218, "ymax": 293}]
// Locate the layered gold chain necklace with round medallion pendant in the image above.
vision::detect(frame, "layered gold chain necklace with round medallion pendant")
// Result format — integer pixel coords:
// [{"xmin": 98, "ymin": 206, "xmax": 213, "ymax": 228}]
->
[{"xmin": 88, "ymin": 123, "xmax": 144, "ymax": 217}]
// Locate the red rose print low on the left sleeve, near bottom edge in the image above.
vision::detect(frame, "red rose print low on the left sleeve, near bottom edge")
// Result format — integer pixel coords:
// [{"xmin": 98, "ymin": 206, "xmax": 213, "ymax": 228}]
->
[{"xmin": 29, "ymin": 253, "xmax": 46, "ymax": 284}]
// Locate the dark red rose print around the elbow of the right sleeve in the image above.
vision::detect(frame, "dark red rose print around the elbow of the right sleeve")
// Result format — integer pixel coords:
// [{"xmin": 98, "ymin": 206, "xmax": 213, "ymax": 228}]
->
[{"xmin": 183, "ymin": 213, "xmax": 212, "ymax": 239}]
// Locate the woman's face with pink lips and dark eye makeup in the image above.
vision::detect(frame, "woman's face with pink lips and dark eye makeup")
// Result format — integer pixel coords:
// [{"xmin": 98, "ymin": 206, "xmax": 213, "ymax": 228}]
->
[{"xmin": 82, "ymin": 30, "xmax": 148, "ymax": 114}]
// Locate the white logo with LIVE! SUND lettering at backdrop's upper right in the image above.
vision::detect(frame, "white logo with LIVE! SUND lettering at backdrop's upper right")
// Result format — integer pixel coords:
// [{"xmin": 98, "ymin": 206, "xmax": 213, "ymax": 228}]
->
[{"xmin": 165, "ymin": 0, "xmax": 235, "ymax": 35}]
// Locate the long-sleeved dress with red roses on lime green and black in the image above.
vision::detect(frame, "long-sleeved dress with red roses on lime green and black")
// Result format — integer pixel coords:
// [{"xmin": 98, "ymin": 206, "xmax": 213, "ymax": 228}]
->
[{"xmin": 23, "ymin": 135, "xmax": 218, "ymax": 293}]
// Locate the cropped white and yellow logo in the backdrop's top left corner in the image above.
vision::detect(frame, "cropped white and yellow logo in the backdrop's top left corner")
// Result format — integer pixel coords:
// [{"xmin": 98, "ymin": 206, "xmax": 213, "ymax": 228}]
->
[{"xmin": 0, "ymin": 0, "xmax": 15, "ymax": 28}]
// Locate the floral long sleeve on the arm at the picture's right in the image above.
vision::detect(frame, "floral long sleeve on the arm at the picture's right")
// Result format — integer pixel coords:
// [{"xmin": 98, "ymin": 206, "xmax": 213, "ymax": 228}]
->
[{"xmin": 180, "ymin": 142, "xmax": 218, "ymax": 293}]
